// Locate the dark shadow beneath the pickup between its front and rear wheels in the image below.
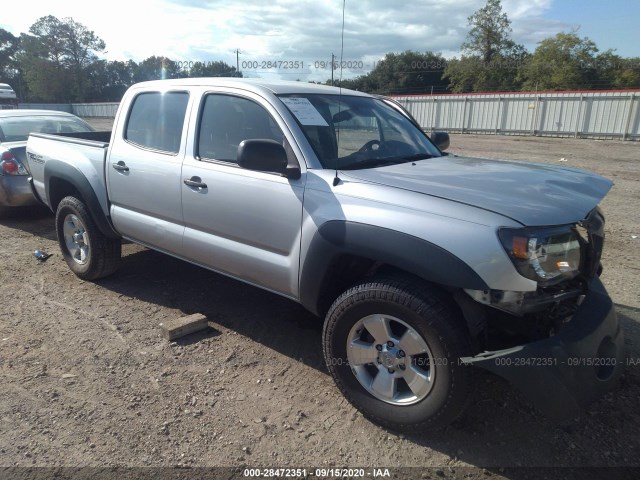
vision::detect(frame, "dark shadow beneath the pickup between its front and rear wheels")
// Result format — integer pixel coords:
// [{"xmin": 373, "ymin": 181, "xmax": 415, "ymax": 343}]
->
[{"xmin": 96, "ymin": 245, "xmax": 327, "ymax": 372}]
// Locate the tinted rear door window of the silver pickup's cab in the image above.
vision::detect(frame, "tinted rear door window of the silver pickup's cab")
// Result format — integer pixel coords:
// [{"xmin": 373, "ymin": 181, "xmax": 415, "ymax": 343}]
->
[{"xmin": 125, "ymin": 92, "xmax": 189, "ymax": 153}]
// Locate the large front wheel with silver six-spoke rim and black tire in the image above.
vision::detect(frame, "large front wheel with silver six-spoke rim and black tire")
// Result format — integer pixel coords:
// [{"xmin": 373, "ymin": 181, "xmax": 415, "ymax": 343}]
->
[{"xmin": 323, "ymin": 277, "xmax": 472, "ymax": 432}]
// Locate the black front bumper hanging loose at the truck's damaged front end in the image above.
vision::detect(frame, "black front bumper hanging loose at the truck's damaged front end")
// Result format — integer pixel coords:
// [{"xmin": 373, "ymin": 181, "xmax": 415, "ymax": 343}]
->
[{"xmin": 461, "ymin": 277, "xmax": 625, "ymax": 420}]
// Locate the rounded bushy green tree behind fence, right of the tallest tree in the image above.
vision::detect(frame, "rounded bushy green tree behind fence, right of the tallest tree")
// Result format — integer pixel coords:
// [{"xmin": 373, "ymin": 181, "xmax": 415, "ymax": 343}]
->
[{"xmin": 521, "ymin": 32, "xmax": 598, "ymax": 90}]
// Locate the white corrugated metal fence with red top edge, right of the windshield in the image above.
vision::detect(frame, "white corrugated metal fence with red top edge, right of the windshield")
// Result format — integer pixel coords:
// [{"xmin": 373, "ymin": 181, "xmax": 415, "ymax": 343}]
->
[{"xmin": 394, "ymin": 90, "xmax": 640, "ymax": 140}]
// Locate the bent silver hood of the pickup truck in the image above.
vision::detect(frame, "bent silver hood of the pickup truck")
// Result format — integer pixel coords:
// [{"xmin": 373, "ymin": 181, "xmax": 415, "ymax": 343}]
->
[{"xmin": 341, "ymin": 156, "xmax": 613, "ymax": 226}]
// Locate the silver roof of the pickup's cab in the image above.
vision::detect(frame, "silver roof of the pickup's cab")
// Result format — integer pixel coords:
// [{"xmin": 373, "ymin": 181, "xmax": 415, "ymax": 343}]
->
[{"xmin": 132, "ymin": 77, "xmax": 370, "ymax": 97}]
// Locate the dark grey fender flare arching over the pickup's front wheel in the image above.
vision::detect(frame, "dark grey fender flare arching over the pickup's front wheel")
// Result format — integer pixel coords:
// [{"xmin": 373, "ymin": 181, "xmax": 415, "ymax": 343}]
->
[{"xmin": 300, "ymin": 220, "xmax": 489, "ymax": 315}]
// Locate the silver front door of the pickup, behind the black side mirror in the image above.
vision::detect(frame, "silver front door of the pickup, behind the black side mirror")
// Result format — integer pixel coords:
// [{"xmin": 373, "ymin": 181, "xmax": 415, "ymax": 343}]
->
[{"xmin": 181, "ymin": 90, "xmax": 306, "ymax": 297}]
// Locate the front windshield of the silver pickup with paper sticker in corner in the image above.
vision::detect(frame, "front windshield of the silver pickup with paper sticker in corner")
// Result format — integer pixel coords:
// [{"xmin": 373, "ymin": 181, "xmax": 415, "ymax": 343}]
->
[{"xmin": 280, "ymin": 94, "xmax": 441, "ymax": 170}]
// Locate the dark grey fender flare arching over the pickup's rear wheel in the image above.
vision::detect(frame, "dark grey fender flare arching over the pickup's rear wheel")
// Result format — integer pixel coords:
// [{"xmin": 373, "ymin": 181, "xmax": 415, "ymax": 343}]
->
[{"xmin": 44, "ymin": 160, "xmax": 121, "ymax": 239}]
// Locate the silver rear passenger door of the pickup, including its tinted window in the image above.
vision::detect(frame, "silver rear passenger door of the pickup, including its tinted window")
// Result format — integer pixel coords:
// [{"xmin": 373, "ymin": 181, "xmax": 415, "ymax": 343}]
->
[{"xmin": 106, "ymin": 90, "xmax": 189, "ymax": 254}]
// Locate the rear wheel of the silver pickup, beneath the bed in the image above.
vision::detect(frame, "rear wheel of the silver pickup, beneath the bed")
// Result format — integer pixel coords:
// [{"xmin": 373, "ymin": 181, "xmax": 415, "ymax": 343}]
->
[{"xmin": 56, "ymin": 197, "xmax": 122, "ymax": 280}]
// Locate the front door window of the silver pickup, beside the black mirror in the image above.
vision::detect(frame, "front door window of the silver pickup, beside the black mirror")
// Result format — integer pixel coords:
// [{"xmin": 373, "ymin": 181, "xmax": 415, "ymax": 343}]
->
[{"xmin": 198, "ymin": 95, "xmax": 284, "ymax": 163}]
